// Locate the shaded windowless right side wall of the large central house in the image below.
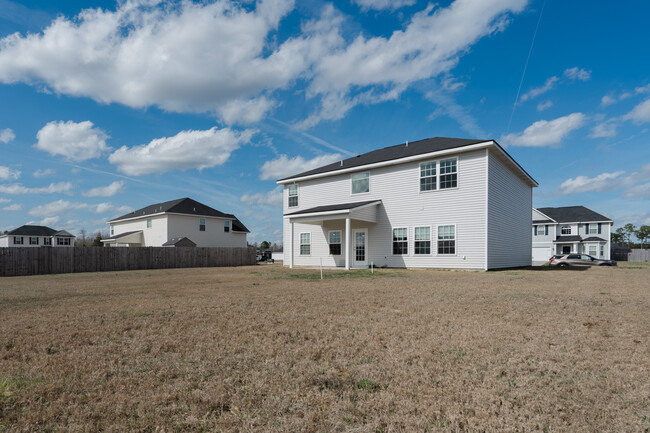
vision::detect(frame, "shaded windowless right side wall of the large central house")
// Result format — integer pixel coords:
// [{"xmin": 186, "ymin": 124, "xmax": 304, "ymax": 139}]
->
[{"xmin": 486, "ymin": 149, "xmax": 532, "ymax": 269}]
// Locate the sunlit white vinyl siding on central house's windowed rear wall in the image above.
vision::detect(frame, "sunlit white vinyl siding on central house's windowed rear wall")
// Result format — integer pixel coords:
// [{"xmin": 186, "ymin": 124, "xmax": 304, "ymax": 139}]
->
[{"xmin": 283, "ymin": 150, "xmax": 488, "ymax": 269}]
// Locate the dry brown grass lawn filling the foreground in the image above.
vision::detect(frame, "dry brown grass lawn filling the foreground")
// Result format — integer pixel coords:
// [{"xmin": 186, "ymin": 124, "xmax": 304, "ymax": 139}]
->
[{"xmin": 0, "ymin": 264, "xmax": 650, "ymax": 432}]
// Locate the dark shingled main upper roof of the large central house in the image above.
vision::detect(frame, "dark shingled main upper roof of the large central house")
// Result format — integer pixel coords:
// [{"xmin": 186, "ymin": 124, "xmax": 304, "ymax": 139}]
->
[{"xmin": 280, "ymin": 137, "xmax": 486, "ymax": 181}]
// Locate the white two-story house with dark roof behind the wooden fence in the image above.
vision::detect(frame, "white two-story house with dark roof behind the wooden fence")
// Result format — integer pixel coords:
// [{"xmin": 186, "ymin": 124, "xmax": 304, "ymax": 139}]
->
[{"xmin": 102, "ymin": 198, "xmax": 249, "ymax": 248}]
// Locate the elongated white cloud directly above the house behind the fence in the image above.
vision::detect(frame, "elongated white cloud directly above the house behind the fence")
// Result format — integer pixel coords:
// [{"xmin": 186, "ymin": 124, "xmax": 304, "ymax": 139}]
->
[{"xmin": 108, "ymin": 127, "xmax": 256, "ymax": 176}]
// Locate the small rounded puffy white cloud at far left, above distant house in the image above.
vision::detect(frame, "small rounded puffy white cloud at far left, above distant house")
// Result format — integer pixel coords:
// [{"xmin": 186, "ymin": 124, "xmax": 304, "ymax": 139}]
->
[{"xmin": 34, "ymin": 120, "xmax": 110, "ymax": 162}]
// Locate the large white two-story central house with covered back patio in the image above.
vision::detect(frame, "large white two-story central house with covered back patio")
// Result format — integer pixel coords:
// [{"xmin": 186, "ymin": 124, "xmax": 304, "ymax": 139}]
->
[{"xmin": 278, "ymin": 137, "xmax": 537, "ymax": 269}]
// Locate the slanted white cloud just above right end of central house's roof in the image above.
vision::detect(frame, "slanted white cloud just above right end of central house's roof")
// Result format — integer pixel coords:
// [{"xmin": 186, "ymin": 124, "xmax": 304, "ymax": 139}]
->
[{"xmin": 501, "ymin": 113, "xmax": 587, "ymax": 147}]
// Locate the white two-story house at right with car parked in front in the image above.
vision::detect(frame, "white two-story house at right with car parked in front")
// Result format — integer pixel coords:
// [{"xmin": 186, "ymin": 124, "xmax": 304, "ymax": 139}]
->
[{"xmin": 532, "ymin": 206, "xmax": 614, "ymax": 264}]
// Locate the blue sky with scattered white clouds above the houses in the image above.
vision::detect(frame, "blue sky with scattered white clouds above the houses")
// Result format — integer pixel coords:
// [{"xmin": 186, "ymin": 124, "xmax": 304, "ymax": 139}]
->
[{"xmin": 0, "ymin": 0, "xmax": 650, "ymax": 243}]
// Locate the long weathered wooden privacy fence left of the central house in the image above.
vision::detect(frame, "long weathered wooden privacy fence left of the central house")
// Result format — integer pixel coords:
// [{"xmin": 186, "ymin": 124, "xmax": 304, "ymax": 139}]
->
[{"xmin": 0, "ymin": 247, "xmax": 256, "ymax": 277}]
